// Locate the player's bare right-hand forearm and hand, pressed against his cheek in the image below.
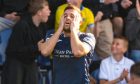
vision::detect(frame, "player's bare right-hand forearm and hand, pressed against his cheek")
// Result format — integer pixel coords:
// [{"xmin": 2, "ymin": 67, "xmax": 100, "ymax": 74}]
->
[{"xmin": 70, "ymin": 15, "xmax": 95, "ymax": 57}]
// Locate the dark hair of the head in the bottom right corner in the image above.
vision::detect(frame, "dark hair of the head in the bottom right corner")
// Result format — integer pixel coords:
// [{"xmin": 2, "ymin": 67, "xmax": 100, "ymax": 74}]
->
[{"xmin": 130, "ymin": 62, "xmax": 140, "ymax": 77}]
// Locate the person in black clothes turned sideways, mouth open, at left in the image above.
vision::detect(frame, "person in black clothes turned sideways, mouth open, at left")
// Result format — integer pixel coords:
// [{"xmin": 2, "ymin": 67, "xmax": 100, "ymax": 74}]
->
[{"xmin": 2, "ymin": 0, "xmax": 50, "ymax": 84}]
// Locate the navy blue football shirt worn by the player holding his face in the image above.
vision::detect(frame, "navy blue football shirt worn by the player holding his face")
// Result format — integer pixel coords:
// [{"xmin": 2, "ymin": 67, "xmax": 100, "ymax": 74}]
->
[{"xmin": 46, "ymin": 33, "xmax": 95, "ymax": 84}]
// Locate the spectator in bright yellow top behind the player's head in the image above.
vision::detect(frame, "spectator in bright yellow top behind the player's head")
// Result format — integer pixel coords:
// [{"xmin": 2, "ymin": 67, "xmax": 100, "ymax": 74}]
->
[{"xmin": 55, "ymin": 0, "xmax": 94, "ymax": 33}]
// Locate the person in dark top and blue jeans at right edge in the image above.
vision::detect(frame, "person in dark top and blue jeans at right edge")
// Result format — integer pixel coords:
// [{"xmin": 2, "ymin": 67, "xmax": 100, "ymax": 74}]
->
[{"xmin": 125, "ymin": 0, "xmax": 140, "ymax": 62}]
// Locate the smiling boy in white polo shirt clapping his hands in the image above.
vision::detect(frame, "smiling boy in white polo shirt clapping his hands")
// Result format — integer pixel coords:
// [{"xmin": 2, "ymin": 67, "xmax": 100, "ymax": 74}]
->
[{"xmin": 99, "ymin": 36, "xmax": 134, "ymax": 84}]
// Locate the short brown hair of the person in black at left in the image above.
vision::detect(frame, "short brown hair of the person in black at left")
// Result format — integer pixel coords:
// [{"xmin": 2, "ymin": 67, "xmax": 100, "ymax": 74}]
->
[{"xmin": 29, "ymin": 0, "xmax": 49, "ymax": 15}]
